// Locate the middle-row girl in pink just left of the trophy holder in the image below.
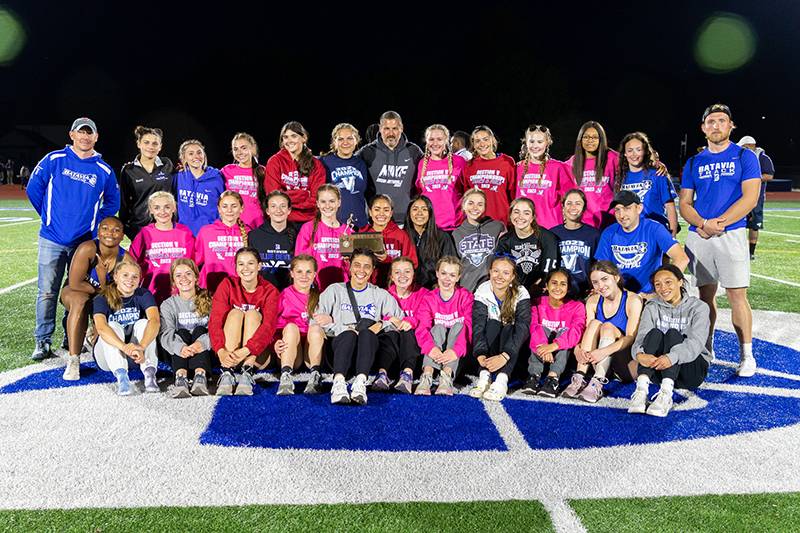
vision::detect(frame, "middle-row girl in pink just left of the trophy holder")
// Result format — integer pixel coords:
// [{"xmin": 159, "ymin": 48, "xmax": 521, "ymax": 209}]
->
[{"xmin": 294, "ymin": 183, "xmax": 353, "ymax": 291}]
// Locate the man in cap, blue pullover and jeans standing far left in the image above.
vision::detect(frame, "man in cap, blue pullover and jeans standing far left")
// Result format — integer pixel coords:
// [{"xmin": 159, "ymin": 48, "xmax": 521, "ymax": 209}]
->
[{"xmin": 26, "ymin": 117, "xmax": 120, "ymax": 364}]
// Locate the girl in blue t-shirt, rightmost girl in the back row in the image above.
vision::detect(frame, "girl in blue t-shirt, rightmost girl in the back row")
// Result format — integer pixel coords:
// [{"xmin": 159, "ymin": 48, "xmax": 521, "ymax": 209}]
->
[{"xmin": 614, "ymin": 131, "xmax": 679, "ymax": 237}]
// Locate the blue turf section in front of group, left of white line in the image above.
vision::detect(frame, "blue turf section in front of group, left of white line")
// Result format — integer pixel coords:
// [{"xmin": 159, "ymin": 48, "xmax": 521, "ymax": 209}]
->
[{"xmin": 200, "ymin": 385, "xmax": 507, "ymax": 452}]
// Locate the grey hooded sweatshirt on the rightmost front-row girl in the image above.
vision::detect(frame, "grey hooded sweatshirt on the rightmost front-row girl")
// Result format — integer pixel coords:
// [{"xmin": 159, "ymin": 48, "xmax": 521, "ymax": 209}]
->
[{"xmin": 631, "ymin": 292, "xmax": 713, "ymax": 365}]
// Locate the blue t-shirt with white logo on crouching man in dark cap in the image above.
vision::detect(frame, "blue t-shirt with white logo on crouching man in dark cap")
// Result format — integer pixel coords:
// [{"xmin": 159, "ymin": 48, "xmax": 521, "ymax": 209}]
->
[{"xmin": 595, "ymin": 217, "xmax": 678, "ymax": 292}]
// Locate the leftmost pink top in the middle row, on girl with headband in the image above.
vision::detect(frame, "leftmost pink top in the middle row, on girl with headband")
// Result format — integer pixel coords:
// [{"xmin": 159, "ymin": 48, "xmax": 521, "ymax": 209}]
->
[{"xmin": 128, "ymin": 224, "xmax": 194, "ymax": 304}]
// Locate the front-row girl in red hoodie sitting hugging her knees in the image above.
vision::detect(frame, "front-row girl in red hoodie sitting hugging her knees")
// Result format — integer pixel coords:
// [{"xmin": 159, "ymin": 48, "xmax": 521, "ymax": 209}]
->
[{"xmin": 208, "ymin": 246, "xmax": 278, "ymax": 396}]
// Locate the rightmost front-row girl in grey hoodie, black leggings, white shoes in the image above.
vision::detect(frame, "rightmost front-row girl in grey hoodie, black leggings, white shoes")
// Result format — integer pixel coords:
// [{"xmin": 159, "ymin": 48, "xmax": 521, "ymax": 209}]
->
[{"xmin": 628, "ymin": 265, "xmax": 711, "ymax": 416}]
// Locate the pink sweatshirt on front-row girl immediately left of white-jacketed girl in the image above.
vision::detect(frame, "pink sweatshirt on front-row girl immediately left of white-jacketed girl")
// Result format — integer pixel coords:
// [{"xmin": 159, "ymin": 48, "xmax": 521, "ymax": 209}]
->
[{"xmin": 416, "ymin": 287, "xmax": 474, "ymax": 357}]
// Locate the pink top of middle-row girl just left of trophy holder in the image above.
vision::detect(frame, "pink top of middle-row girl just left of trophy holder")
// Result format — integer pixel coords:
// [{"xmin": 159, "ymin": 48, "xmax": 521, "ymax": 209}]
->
[{"xmin": 294, "ymin": 220, "xmax": 352, "ymax": 292}]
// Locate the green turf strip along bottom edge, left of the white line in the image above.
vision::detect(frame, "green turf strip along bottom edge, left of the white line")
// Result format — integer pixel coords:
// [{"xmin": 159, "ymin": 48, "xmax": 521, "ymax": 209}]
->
[{"xmin": 0, "ymin": 500, "xmax": 553, "ymax": 533}]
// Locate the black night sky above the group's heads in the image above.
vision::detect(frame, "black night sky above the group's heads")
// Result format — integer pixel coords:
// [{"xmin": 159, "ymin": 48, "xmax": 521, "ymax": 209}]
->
[{"xmin": 0, "ymin": 1, "xmax": 800, "ymax": 173}]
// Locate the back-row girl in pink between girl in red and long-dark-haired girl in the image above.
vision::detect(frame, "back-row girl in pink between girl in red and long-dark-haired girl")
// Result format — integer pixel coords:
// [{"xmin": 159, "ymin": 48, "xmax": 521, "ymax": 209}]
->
[{"xmin": 516, "ymin": 124, "xmax": 575, "ymax": 229}]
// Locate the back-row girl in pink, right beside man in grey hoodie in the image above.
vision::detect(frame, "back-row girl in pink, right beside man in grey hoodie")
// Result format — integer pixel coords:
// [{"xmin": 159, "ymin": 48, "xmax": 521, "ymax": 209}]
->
[{"xmin": 417, "ymin": 124, "xmax": 466, "ymax": 231}]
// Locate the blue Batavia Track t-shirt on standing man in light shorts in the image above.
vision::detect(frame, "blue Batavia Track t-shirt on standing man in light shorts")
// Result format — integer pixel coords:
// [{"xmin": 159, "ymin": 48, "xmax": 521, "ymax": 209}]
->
[{"xmin": 681, "ymin": 143, "xmax": 761, "ymax": 231}]
